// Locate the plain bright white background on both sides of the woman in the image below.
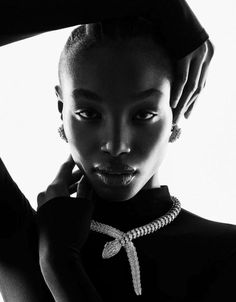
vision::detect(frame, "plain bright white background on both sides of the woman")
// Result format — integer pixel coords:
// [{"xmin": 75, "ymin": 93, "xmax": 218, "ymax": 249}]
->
[{"xmin": 0, "ymin": 0, "xmax": 236, "ymax": 301}]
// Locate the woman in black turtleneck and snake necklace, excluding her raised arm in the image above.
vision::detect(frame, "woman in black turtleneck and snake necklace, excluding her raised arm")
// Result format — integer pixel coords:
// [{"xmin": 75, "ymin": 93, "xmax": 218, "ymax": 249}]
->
[{"xmin": 37, "ymin": 18, "xmax": 236, "ymax": 301}]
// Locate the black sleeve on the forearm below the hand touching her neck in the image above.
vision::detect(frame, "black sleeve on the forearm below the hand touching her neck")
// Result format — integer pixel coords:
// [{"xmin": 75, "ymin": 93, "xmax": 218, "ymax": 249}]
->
[{"xmin": 37, "ymin": 197, "xmax": 102, "ymax": 302}]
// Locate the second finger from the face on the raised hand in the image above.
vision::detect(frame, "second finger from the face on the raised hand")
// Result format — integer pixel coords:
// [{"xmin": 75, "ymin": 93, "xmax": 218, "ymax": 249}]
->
[{"xmin": 174, "ymin": 59, "xmax": 205, "ymax": 123}]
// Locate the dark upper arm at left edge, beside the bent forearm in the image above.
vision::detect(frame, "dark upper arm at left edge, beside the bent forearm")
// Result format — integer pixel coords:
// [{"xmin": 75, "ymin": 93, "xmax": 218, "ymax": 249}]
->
[{"xmin": 0, "ymin": 158, "xmax": 54, "ymax": 302}]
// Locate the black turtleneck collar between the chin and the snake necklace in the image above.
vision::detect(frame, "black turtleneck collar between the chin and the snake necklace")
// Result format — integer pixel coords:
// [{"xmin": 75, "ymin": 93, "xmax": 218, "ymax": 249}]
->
[{"xmin": 93, "ymin": 186, "xmax": 173, "ymax": 232}]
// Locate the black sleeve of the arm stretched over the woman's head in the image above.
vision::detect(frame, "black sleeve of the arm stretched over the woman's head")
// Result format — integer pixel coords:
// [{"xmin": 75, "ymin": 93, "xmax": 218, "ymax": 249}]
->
[{"xmin": 0, "ymin": 0, "xmax": 208, "ymax": 58}]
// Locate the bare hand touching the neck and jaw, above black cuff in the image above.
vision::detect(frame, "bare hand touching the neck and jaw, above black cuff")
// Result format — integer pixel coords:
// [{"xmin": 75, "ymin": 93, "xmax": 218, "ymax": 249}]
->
[{"xmin": 37, "ymin": 155, "xmax": 92, "ymax": 209}]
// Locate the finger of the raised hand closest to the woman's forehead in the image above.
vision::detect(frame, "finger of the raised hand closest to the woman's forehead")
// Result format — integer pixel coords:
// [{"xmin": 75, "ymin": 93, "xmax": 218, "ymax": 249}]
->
[{"xmin": 170, "ymin": 56, "xmax": 190, "ymax": 108}]
